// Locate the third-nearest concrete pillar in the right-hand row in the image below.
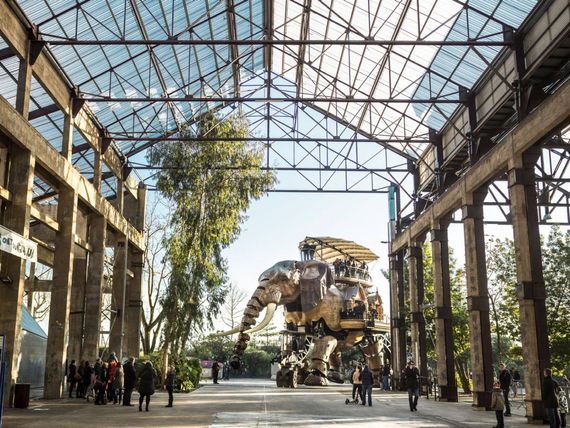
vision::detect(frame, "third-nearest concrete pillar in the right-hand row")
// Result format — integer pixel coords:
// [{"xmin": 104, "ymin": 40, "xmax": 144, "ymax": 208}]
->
[{"xmin": 430, "ymin": 219, "xmax": 457, "ymax": 401}]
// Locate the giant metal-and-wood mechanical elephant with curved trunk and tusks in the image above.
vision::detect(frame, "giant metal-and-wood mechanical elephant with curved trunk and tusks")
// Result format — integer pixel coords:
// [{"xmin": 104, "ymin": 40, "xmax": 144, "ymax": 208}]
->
[{"xmin": 216, "ymin": 260, "xmax": 381, "ymax": 385}]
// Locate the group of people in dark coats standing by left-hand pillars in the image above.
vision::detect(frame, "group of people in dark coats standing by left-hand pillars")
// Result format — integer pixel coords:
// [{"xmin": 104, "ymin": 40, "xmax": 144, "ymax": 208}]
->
[{"xmin": 67, "ymin": 353, "xmax": 176, "ymax": 412}]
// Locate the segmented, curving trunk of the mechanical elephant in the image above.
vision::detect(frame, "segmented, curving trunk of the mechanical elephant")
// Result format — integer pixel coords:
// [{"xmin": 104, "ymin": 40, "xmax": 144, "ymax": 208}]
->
[{"xmin": 230, "ymin": 285, "xmax": 281, "ymax": 369}]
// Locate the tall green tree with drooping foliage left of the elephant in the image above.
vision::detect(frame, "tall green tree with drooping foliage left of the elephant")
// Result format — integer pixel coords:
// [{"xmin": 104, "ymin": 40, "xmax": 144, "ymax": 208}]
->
[{"xmin": 148, "ymin": 113, "xmax": 275, "ymax": 352}]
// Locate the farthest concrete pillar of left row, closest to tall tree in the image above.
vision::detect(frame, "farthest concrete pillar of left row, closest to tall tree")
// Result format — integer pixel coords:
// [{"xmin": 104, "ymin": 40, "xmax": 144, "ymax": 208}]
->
[{"xmin": 123, "ymin": 249, "xmax": 144, "ymax": 357}]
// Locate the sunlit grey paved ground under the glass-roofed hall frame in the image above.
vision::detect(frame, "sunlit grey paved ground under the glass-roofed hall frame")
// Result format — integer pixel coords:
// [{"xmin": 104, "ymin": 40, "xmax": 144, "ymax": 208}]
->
[{"xmin": 3, "ymin": 379, "xmax": 528, "ymax": 428}]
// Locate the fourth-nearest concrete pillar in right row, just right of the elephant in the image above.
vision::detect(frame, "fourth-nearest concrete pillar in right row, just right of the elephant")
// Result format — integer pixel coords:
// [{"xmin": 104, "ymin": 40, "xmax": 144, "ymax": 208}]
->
[{"xmin": 408, "ymin": 242, "xmax": 427, "ymax": 386}]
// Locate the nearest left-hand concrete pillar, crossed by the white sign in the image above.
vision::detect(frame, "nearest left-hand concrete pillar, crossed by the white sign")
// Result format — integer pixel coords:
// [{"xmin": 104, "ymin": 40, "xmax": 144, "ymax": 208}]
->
[{"xmin": 0, "ymin": 145, "xmax": 35, "ymax": 406}]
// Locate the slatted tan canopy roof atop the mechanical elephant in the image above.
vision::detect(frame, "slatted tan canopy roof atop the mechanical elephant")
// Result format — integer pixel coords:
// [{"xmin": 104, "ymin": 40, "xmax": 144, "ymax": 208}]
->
[{"xmin": 299, "ymin": 236, "xmax": 378, "ymax": 263}]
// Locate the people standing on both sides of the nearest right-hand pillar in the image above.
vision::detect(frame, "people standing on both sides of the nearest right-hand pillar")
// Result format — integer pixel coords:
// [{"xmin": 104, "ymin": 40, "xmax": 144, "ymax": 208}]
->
[{"xmin": 491, "ymin": 363, "xmax": 568, "ymax": 428}]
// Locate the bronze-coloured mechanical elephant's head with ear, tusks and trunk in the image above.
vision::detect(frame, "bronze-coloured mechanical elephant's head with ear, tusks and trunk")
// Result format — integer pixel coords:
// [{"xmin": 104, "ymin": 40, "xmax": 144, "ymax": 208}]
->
[{"xmin": 219, "ymin": 260, "xmax": 334, "ymax": 368}]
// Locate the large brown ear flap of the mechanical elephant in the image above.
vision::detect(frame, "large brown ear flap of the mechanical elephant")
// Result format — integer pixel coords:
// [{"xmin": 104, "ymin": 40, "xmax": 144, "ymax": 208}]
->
[{"xmin": 299, "ymin": 261, "xmax": 334, "ymax": 312}]
